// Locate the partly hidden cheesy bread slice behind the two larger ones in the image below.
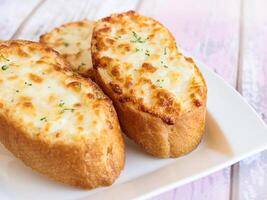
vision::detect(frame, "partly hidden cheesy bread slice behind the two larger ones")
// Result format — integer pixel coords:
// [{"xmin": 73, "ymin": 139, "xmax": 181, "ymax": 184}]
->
[{"xmin": 40, "ymin": 20, "xmax": 94, "ymax": 78}]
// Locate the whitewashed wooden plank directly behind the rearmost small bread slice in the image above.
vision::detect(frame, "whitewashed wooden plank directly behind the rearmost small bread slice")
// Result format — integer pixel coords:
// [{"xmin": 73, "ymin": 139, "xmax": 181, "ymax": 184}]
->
[{"xmin": 12, "ymin": 0, "xmax": 139, "ymax": 40}]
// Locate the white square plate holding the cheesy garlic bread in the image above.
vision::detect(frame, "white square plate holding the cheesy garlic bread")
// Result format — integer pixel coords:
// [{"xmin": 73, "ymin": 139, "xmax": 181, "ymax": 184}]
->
[{"xmin": 0, "ymin": 63, "xmax": 267, "ymax": 200}]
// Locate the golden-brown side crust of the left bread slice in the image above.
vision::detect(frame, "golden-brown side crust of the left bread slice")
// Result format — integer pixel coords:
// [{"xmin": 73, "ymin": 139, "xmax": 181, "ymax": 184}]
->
[{"xmin": 0, "ymin": 41, "xmax": 125, "ymax": 189}]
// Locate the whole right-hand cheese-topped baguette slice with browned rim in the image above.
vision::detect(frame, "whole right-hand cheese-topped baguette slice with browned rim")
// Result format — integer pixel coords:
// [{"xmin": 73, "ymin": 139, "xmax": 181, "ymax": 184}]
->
[{"xmin": 92, "ymin": 11, "xmax": 207, "ymax": 157}]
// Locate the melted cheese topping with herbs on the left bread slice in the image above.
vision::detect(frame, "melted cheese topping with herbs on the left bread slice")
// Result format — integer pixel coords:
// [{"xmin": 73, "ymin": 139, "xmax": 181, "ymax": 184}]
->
[{"xmin": 0, "ymin": 41, "xmax": 116, "ymax": 141}]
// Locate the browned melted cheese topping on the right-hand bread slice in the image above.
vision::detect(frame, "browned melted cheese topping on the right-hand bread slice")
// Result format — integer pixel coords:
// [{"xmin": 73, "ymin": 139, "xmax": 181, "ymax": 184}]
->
[{"xmin": 92, "ymin": 11, "xmax": 206, "ymax": 123}]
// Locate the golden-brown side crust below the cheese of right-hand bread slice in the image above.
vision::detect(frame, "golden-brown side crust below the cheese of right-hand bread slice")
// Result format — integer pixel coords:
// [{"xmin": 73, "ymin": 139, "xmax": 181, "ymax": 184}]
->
[{"xmin": 96, "ymin": 71, "xmax": 206, "ymax": 158}]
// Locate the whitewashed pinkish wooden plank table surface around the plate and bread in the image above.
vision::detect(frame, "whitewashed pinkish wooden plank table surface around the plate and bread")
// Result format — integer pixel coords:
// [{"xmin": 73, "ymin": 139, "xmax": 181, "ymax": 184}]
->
[{"xmin": 0, "ymin": 0, "xmax": 267, "ymax": 200}]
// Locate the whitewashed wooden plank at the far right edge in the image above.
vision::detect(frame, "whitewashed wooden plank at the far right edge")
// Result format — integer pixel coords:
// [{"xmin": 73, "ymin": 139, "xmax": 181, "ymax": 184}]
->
[{"xmin": 233, "ymin": 0, "xmax": 267, "ymax": 200}]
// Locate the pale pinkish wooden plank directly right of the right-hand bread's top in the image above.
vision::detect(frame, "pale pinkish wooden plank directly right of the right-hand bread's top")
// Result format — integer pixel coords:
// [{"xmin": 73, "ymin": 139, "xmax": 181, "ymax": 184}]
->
[{"xmin": 138, "ymin": 0, "xmax": 243, "ymax": 200}]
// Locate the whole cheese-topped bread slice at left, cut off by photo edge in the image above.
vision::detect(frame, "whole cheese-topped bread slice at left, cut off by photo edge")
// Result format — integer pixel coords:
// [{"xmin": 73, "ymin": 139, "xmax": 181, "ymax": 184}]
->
[{"xmin": 0, "ymin": 41, "xmax": 124, "ymax": 188}]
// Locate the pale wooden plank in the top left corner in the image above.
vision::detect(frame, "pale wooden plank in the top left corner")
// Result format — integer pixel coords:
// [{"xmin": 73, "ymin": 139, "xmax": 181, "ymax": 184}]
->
[{"xmin": 0, "ymin": 0, "xmax": 41, "ymax": 40}]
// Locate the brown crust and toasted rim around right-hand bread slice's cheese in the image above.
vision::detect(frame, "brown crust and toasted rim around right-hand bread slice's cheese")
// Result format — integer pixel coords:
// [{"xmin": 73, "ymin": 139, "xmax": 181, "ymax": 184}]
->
[{"xmin": 92, "ymin": 11, "xmax": 207, "ymax": 158}]
